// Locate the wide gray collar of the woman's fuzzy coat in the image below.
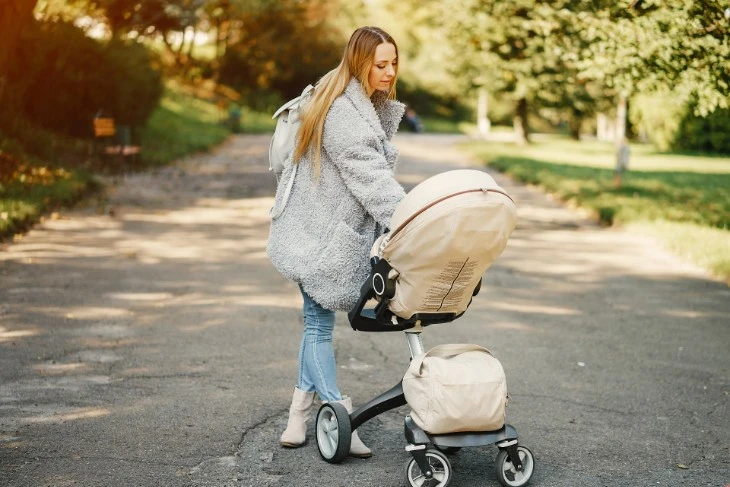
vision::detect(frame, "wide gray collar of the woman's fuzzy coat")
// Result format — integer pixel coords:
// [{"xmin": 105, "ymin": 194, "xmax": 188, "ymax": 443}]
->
[{"xmin": 345, "ymin": 78, "xmax": 406, "ymax": 140}]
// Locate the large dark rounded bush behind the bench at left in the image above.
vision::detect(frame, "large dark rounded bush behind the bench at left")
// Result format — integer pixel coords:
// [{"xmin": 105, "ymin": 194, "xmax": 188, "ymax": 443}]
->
[{"xmin": 6, "ymin": 21, "xmax": 161, "ymax": 137}]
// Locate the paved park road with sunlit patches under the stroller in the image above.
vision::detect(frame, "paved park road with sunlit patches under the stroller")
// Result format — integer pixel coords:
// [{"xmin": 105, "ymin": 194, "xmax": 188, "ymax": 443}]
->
[{"xmin": 0, "ymin": 135, "xmax": 730, "ymax": 487}]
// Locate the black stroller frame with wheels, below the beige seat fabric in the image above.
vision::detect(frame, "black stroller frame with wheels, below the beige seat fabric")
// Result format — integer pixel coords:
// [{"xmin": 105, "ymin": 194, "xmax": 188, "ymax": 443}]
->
[{"xmin": 316, "ymin": 257, "xmax": 534, "ymax": 487}]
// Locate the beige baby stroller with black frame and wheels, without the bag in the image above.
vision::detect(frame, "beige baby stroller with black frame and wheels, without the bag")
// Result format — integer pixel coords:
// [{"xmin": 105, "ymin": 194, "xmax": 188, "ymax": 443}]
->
[{"xmin": 315, "ymin": 169, "xmax": 534, "ymax": 487}]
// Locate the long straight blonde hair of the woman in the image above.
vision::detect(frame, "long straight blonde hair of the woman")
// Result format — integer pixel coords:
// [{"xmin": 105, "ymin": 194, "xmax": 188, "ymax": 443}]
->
[{"xmin": 293, "ymin": 27, "xmax": 398, "ymax": 175}]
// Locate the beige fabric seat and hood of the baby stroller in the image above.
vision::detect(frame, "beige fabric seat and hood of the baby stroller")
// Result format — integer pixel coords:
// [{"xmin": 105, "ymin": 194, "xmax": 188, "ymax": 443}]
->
[{"xmin": 372, "ymin": 169, "xmax": 516, "ymax": 319}]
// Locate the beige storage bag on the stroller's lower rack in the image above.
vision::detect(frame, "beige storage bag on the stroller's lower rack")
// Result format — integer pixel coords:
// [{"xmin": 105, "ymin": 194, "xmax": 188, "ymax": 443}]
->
[{"xmin": 403, "ymin": 344, "xmax": 508, "ymax": 434}]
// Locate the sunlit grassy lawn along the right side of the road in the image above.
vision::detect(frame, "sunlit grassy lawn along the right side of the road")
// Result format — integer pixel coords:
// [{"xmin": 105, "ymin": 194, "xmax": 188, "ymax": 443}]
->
[{"xmin": 464, "ymin": 137, "xmax": 730, "ymax": 280}]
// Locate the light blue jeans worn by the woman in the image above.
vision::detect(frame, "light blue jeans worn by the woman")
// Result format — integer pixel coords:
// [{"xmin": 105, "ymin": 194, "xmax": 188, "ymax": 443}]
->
[{"xmin": 297, "ymin": 287, "xmax": 342, "ymax": 401}]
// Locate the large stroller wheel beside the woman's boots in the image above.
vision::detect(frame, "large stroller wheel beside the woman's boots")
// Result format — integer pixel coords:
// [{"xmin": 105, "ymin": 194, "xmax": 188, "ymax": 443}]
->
[{"xmin": 315, "ymin": 402, "xmax": 352, "ymax": 463}]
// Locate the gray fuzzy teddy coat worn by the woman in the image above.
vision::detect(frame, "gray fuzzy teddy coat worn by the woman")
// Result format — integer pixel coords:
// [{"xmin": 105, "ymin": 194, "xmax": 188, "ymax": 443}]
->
[{"xmin": 267, "ymin": 78, "xmax": 405, "ymax": 311}]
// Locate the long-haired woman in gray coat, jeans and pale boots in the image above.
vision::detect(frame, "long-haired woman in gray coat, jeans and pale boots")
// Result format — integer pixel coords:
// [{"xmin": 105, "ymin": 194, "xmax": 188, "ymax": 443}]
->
[{"xmin": 267, "ymin": 27, "xmax": 405, "ymax": 458}]
